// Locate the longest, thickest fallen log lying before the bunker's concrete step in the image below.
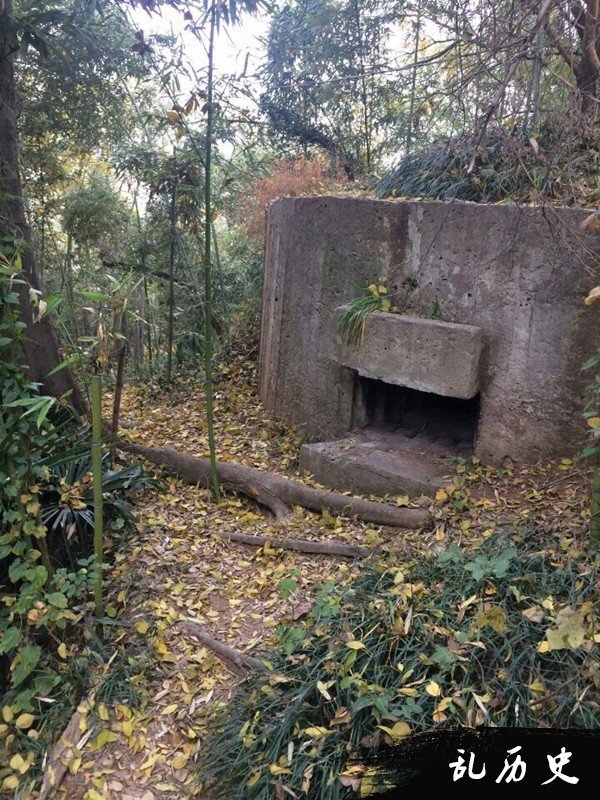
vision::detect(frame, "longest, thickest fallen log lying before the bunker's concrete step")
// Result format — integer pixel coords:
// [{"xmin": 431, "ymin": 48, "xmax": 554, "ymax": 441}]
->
[{"xmin": 117, "ymin": 439, "xmax": 429, "ymax": 530}]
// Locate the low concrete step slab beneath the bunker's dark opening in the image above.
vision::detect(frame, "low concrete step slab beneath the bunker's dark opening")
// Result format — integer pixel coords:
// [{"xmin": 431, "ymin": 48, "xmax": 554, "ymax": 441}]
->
[{"xmin": 300, "ymin": 428, "xmax": 468, "ymax": 497}]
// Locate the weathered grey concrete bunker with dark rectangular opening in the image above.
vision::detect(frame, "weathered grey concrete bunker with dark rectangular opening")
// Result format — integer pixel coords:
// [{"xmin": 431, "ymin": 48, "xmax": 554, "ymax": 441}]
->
[{"xmin": 260, "ymin": 197, "xmax": 600, "ymax": 495}]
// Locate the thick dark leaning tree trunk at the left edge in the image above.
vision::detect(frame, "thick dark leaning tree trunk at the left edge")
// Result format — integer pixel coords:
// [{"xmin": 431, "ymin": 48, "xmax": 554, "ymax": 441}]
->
[{"xmin": 0, "ymin": 6, "xmax": 86, "ymax": 413}]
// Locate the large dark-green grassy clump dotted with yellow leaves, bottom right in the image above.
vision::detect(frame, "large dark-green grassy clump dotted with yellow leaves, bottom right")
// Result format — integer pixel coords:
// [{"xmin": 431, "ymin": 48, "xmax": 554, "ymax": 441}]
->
[{"xmin": 200, "ymin": 530, "xmax": 600, "ymax": 800}]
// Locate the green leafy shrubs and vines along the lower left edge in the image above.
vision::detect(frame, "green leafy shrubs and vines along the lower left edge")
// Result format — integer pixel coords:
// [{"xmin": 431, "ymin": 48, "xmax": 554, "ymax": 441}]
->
[{"xmin": 0, "ymin": 250, "xmax": 152, "ymax": 791}]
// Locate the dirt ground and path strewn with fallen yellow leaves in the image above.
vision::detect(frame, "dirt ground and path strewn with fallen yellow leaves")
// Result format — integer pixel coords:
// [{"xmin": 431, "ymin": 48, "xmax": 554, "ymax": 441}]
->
[{"xmin": 44, "ymin": 356, "xmax": 588, "ymax": 800}]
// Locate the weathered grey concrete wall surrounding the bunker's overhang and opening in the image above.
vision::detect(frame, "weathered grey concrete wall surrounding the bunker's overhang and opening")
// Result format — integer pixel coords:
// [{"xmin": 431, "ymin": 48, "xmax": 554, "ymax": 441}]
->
[{"xmin": 261, "ymin": 197, "xmax": 600, "ymax": 458}]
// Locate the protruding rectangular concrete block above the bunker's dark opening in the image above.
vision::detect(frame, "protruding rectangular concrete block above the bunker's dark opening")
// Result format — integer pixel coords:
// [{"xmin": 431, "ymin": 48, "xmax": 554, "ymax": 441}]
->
[{"xmin": 331, "ymin": 306, "xmax": 483, "ymax": 400}]
